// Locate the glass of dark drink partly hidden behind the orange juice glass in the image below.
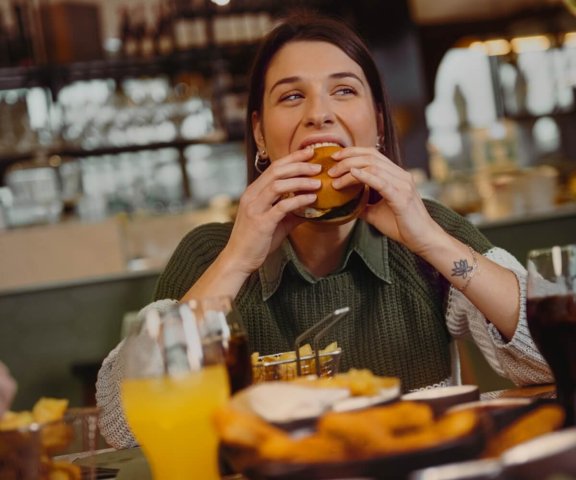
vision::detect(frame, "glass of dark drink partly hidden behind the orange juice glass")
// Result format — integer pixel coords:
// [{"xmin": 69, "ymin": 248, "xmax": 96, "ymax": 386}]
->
[{"xmin": 188, "ymin": 295, "xmax": 252, "ymax": 393}]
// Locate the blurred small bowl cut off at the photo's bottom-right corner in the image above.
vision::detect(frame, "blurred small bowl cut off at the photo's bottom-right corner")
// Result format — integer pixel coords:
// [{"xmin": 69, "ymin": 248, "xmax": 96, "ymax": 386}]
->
[{"xmin": 501, "ymin": 427, "xmax": 576, "ymax": 480}]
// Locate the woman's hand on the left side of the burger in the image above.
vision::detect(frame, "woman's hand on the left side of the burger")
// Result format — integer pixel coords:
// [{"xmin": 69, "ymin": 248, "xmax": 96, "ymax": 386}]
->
[{"xmin": 225, "ymin": 148, "xmax": 322, "ymax": 274}]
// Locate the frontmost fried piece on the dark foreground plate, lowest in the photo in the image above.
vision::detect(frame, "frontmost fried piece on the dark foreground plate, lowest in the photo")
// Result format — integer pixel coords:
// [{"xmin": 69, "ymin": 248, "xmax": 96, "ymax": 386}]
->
[{"xmin": 259, "ymin": 434, "xmax": 347, "ymax": 463}]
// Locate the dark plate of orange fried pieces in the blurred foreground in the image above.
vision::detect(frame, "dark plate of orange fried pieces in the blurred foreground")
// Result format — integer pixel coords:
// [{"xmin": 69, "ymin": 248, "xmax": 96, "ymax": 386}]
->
[{"xmin": 216, "ymin": 401, "xmax": 485, "ymax": 480}]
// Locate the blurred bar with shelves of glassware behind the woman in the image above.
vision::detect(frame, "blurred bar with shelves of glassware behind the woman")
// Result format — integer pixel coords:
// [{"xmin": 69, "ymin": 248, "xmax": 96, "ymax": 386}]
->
[{"xmin": 0, "ymin": 0, "xmax": 576, "ymax": 408}]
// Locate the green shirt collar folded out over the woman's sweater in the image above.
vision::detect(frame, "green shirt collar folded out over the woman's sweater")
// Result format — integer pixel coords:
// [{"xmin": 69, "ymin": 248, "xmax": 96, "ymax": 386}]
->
[{"xmin": 259, "ymin": 220, "xmax": 390, "ymax": 301}]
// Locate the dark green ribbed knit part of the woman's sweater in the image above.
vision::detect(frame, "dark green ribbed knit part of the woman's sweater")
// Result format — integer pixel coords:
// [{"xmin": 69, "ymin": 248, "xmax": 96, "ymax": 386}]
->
[{"xmin": 155, "ymin": 201, "xmax": 492, "ymax": 391}]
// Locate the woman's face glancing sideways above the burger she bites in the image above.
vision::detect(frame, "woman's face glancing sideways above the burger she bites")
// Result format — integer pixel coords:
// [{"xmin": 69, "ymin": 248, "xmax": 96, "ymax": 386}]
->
[{"xmin": 253, "ymin": 41, "xmax": 378, "ymax": 161}]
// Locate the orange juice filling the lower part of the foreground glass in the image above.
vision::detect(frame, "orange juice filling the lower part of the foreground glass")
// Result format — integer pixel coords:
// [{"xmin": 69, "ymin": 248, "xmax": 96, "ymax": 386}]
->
[{"xmin": 122, "ymin": 365, "xmax": 229, "ymax": 480}]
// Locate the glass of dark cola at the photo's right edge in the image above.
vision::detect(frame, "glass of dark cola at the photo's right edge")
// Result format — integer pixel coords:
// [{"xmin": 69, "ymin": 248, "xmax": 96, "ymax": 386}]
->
[{"xmin": 526, "ymin": 244, "xmax": 576, "ymax": 426}]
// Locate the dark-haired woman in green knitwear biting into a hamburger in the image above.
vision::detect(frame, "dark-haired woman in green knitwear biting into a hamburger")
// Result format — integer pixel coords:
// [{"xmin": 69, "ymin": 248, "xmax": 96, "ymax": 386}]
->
[{"xmin": 97, "ymin": 17, "xmax": 551, "ymax": 446}]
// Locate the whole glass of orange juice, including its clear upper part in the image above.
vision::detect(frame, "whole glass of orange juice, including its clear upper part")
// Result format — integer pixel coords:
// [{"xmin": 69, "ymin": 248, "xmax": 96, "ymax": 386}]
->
[{"xmin": 121, "ymin": 305, "xmax": 229, "ymax": 480}]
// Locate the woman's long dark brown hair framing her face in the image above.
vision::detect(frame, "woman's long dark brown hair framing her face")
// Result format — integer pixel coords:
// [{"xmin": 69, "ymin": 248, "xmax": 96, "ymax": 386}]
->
[{"xmin": 246, "ymin": 12, "xmax": 401, "ymax": 183}]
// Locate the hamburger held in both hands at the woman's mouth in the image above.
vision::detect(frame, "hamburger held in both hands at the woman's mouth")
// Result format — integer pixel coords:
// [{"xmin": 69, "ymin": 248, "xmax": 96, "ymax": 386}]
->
[{"xmin": 294, "ymin": 143, "xmax": 368, "ymax": 224}]
